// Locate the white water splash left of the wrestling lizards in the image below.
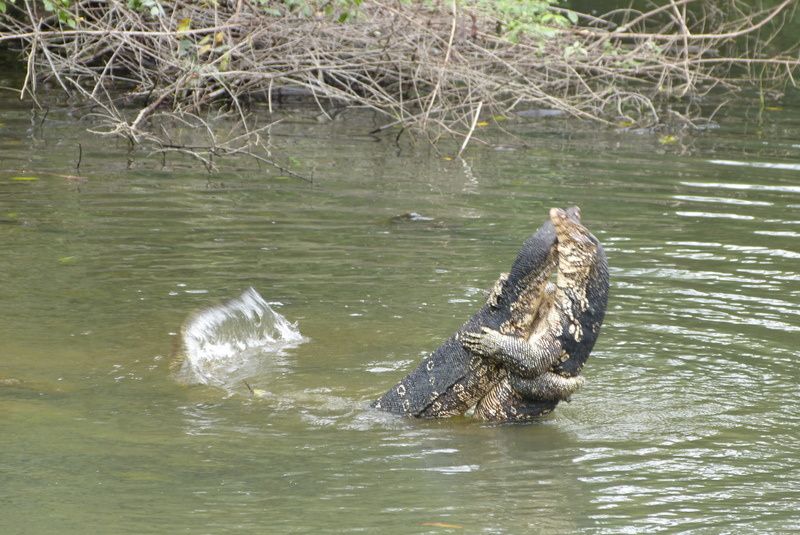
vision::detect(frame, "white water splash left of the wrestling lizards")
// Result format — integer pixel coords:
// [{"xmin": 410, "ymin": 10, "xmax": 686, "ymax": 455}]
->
[{"xmin": 177, "ymin": 288, "xmax": 306, "ymax": 392}]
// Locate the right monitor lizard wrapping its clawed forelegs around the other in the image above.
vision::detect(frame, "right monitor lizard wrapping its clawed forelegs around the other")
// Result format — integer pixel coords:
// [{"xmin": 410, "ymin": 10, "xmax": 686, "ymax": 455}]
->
[{"xmin": 463, "ymin": 208, "xmax": 608, "ymax": 421}]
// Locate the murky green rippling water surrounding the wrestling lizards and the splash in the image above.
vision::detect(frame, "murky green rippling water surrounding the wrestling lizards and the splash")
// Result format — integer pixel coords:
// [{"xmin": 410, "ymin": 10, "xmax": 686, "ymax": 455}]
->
[{"xmin": 0, "ymin": 81, "xmax": 800, "ymax": 534}]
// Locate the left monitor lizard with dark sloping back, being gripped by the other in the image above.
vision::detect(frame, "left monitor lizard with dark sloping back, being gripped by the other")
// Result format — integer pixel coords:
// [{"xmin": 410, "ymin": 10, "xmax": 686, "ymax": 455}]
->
[{"xmin": 373, "ymin": 209, "xmax": 577, "ymax": 418}]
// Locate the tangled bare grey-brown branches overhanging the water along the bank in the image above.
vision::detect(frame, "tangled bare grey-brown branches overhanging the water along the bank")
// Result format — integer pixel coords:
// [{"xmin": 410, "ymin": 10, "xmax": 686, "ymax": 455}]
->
[{"xmin": 0, "ymin": 0, "xmax": 800, "ymax": 161}]
